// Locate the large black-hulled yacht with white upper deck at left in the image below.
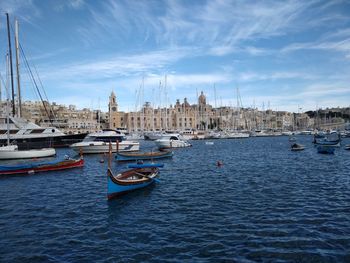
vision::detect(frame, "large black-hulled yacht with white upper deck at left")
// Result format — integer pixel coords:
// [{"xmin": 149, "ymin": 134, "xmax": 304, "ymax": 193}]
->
[{"xmin": 0, "ymin": 116, "xmax": 86, "ymax": 150}]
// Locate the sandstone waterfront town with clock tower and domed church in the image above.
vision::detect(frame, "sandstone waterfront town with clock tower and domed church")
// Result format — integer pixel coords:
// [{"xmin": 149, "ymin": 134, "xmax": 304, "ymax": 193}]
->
[{"xmin": 1, "ymin": 92, "xmax": 350, "ymax": 134}]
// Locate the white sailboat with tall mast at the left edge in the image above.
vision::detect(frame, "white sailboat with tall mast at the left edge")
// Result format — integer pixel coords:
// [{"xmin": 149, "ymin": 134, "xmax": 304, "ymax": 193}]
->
[{"xmin": 0, "ymin": 14, "xmax": 56, "ymax": 160}]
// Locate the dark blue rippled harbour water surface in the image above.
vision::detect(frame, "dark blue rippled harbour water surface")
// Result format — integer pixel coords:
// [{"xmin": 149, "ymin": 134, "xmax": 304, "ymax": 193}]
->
[{"xmin": 0, "ymin": 136, "xmax": 350, "ymax": 262}]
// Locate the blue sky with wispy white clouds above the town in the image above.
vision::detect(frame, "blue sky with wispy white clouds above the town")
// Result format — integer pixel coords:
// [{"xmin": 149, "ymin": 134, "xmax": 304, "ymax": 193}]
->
[{"xmin": 0, "ymin": 0, "xmax": 350, "ymax": 112}]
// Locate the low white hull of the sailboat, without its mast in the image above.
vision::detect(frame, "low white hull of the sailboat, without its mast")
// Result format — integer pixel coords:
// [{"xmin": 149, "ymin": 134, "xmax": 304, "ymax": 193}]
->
[{"xmin": 0, "ymin": 145, "xmax": 56, "ymax": 160}]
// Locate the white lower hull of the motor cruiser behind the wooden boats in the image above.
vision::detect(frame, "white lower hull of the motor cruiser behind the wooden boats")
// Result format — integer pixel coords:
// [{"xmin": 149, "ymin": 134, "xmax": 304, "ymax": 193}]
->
[{"xmin": 70, "ymin": 141, "xmax": 140, "ymax": 154}]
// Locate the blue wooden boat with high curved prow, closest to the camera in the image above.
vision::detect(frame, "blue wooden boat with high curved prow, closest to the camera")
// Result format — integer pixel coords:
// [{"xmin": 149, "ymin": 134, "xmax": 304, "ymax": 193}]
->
[{"xmin": 107, "ymin": 167, "xmax": 159, "ymax": 199}]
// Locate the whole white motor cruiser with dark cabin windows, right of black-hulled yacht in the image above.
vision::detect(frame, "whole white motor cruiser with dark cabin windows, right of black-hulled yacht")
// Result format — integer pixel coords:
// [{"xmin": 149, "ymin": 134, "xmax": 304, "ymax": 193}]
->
[{"xmin": 70, "ymin": 130, "xmax": 140, "ymax": 153}]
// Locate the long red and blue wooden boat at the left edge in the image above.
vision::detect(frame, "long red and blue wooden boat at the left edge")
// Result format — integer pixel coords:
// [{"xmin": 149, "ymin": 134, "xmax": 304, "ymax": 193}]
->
[{"xmin": 0, "ymin": 158, "xmax": 84, "ymax": 175}]
